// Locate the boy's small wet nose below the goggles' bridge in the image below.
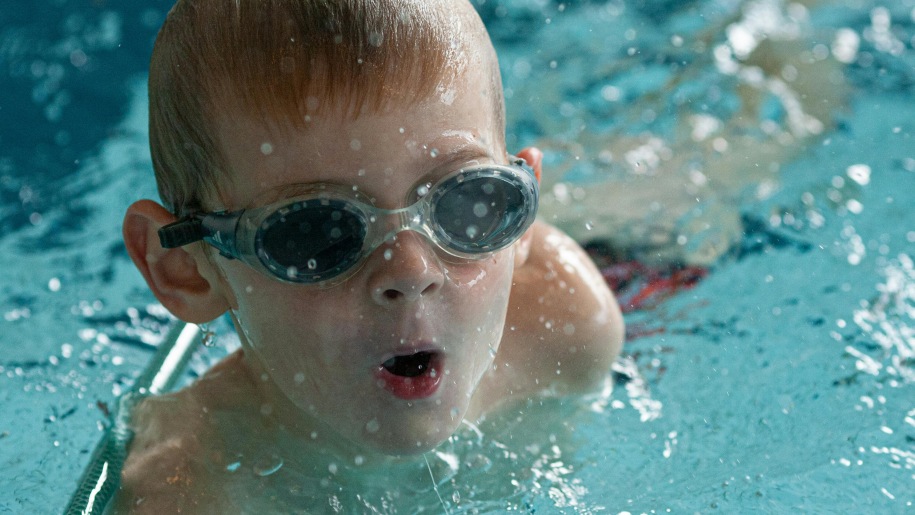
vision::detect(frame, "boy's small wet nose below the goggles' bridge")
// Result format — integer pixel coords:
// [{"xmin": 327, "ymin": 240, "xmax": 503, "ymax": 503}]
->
[{"xmin": 369, "ymin": 231, "xmax": 445, "ymax": 305}]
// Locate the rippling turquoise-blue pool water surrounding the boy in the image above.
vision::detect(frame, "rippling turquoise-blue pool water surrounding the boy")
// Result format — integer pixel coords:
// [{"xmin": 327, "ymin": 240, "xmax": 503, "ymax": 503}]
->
[{"xmin": 0, "ymin": 0, "xmax": 915, "ymax": 513}]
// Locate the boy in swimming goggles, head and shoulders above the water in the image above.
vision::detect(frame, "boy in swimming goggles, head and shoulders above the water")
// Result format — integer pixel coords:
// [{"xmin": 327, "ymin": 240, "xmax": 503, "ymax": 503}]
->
[{"xmin": 117, "ymin": 0, "xmax": 623, "ymax": 513}]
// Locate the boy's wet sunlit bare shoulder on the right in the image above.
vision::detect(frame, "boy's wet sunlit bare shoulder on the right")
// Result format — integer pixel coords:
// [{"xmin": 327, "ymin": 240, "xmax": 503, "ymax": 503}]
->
[{"xmin": 480, "ymin": 221, "xmax": 623, "ymax": 412}]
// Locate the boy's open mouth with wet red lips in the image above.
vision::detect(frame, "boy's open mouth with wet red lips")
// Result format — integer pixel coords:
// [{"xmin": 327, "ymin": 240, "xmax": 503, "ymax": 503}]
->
[{"xmin": 376, "ymin": 351, "xmax": 442, "ymax": 400}]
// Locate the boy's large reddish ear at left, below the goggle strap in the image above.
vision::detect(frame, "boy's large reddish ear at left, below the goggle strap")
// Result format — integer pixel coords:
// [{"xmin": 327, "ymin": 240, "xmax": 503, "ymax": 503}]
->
[{"xmin": 123, "ymin": 200, "xmax": 229, "ymax": 324}]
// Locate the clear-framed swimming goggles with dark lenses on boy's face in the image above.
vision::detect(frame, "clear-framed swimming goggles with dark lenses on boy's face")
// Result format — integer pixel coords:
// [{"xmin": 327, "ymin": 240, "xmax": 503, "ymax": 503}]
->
[{"xmin": 159, "ymin": 158, "xmax": 539, "ymax": 286}]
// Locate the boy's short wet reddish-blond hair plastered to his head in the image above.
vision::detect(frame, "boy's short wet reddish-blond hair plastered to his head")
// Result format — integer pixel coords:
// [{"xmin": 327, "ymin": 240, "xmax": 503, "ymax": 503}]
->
[{"xmin": 149, "ymin": 0, "xmax": 504, "ymax": 216}]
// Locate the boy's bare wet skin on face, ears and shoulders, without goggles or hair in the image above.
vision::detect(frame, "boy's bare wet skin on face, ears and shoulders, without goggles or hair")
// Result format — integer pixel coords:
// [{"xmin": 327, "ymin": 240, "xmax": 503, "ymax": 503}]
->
[{"xmin": 121, "ymin": 37, "xmax": 623, "ymax": 506}]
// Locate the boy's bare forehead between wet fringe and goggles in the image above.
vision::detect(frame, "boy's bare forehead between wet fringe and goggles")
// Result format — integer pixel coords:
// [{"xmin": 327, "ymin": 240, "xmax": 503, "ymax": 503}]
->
[{"xmin": 212, "ymin": 92, "xmax": 505, "ymax": 208}]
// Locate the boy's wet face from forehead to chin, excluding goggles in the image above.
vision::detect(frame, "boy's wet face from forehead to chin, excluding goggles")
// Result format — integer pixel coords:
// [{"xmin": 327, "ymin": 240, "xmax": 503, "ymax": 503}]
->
[{"xmin": 211, "ymin": 64, "xmax": 515, "ymax": 454}]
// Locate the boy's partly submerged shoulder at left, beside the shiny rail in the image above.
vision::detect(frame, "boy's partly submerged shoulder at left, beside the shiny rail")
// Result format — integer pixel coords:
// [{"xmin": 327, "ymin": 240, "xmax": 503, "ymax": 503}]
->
[{"xmin": 113, "ymin": 348, "xmax": 254, "ymax": 513}]
